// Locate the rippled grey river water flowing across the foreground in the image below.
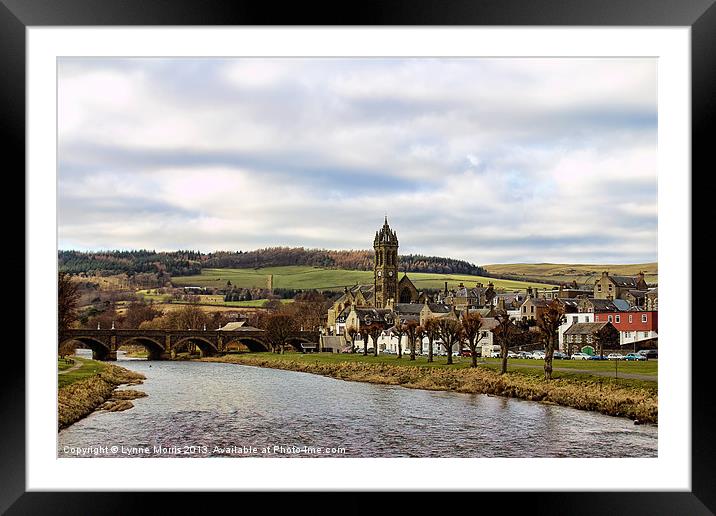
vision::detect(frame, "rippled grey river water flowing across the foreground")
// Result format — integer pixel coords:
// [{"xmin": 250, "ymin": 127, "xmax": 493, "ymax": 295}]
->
[{"xmin": 58, "ymin": 354, "xmax": 657, "ymax": 457}]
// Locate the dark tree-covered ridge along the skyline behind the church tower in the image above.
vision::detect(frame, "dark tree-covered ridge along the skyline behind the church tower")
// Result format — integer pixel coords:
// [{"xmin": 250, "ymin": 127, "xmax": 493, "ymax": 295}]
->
[{"xmin": 58, "ymin": 247, "xmax": 485, "ymax": 277}]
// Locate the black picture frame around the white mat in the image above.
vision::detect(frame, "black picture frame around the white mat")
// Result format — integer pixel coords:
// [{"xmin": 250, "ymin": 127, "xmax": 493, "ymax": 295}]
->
[{"xmin": 0, "ymin": 0, "xmax": 716, "ymax": 515}]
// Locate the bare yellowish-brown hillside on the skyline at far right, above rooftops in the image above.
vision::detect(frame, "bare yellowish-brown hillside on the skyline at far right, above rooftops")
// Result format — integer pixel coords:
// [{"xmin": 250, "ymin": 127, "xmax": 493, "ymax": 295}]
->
[{"xmin": 483, "ymin": 262, "xmax": 659, "ymax": 285}]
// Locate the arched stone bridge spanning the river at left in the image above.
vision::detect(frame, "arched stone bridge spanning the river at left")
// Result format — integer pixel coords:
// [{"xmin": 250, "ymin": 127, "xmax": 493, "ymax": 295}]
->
[{"xmin": 59, "ymin": 327, "xmax": 319, "ymax": 360}]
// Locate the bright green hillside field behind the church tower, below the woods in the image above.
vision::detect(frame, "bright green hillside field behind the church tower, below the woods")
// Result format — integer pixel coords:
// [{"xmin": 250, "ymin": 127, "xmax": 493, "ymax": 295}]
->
[{"xmin": 172, "ymin": 266, "xmax": 550, "ymax": 292}]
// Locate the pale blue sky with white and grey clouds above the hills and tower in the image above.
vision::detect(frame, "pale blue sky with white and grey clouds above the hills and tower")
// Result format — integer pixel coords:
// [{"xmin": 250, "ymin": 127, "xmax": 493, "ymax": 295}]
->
[{"xmin": 58, "ymin": 58, "xmax": 657, "ymax": 264}]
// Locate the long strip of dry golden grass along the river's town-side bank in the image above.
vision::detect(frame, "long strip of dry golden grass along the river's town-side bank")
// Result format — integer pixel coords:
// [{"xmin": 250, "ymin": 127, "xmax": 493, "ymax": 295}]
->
[{"xmin": 202, "ymin": 353, "xmax": 658, "ymax": 423}]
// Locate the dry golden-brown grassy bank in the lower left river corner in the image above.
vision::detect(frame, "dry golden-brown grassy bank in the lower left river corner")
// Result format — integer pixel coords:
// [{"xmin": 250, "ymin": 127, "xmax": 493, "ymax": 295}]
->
[{"xmin": 57, "ymin": 357, "xmax": 146, "ymax": 429}]
